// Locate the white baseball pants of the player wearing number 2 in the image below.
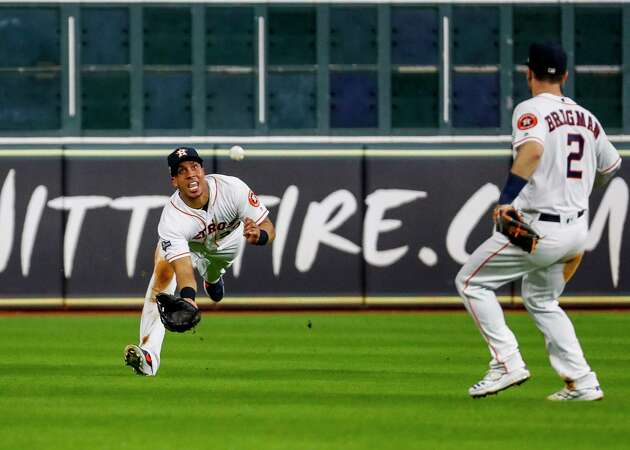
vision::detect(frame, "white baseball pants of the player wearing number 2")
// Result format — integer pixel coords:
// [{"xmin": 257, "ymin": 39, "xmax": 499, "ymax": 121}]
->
[{"xmin": 455, "ymin": 214, "xmax": 599, "ymax": 388}]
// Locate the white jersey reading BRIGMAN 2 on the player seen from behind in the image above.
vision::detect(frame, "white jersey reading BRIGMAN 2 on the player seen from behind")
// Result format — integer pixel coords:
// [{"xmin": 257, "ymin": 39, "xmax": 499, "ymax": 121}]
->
[{"xmin": 512, "ymin": 93, "xmax": 621, "ymax": 214}]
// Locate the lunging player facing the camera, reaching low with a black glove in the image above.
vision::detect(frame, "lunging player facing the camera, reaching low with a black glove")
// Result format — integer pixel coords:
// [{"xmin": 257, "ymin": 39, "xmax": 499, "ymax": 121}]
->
[{"xmin": 124, "ymin": 147, "xmax": 275, "ymax": 376}]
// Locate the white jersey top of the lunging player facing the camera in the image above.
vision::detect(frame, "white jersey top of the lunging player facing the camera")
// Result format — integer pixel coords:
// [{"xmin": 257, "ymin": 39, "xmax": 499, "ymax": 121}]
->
[{"xmin": 158, "ymin": 174, "xmax": 269, "ymax": 262}]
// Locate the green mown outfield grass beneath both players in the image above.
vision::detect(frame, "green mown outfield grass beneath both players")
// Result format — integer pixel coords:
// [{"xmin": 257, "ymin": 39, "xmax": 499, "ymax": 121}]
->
[{"xmin": 0, "ymin": 312, "xmax": 630, "ymax": 450}]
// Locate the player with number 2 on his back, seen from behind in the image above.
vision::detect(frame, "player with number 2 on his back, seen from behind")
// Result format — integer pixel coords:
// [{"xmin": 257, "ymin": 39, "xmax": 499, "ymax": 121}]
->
[{"xmin": 455, "ymin": 44, "xmax": 621, "ymax": 400}]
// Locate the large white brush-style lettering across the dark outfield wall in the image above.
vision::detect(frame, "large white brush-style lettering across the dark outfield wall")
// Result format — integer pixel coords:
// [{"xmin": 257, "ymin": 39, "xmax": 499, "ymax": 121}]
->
[{"xmin": 0, "ymin": 169, "xmax": 630, "ymax": 287}]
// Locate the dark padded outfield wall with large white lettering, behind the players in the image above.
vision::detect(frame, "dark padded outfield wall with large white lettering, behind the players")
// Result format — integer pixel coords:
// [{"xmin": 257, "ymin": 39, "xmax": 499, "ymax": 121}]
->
[{"xmin": 0, "ymin": 143, "xmax": 630, "ymax": 308}]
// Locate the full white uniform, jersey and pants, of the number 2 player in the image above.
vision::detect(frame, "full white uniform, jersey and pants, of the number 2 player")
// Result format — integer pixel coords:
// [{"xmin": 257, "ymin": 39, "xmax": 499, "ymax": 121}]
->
[{"xmin": 455, "ymin": 93, "xmax": 621, "ymax": 389}]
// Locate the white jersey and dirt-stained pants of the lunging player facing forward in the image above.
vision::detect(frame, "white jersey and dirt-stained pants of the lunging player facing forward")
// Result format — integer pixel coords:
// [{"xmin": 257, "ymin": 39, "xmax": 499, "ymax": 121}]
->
[{"xmin": 140, "ymin": 174, "xmax": 269, "ymax": 375}]
